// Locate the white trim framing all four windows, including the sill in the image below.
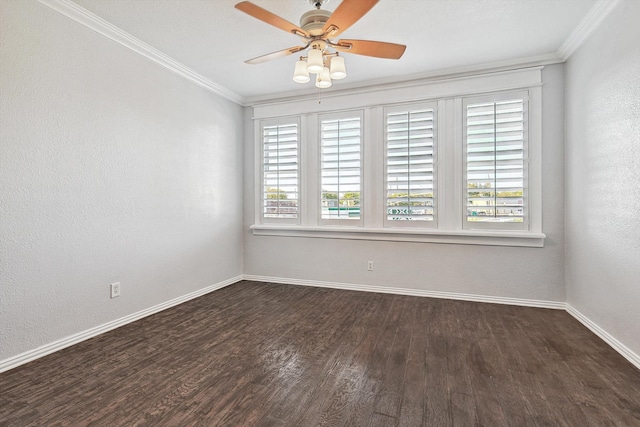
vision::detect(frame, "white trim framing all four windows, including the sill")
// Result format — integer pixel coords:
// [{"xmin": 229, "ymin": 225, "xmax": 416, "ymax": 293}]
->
[{"xmin": 250, "ymin": 66, "xmax": 546, "ymax": 247}]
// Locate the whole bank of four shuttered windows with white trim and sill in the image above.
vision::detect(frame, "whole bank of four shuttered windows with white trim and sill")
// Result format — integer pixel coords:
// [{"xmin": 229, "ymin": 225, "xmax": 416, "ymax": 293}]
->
[{"xmin": 251, "ymin": 67, "xmax": 546, "ymax": 247}]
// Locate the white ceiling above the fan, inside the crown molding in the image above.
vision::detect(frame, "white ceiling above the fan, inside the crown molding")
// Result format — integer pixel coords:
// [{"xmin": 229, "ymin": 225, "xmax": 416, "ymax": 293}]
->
[{"xmin": 73, "ymin": 0, "xmax": 602, "ymax": 99}]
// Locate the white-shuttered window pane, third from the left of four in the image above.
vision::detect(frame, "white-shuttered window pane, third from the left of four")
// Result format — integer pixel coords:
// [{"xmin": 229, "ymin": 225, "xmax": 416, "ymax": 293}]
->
[{"xmin": 385, "ymin": 104, "xmax": 437, "ymax": 227}]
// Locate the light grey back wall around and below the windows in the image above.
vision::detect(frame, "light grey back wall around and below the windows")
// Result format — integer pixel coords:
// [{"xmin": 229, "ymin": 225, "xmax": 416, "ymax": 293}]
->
[{"xmin": 244, "ymin": 65, "xmax": 565, "ymax": 301}]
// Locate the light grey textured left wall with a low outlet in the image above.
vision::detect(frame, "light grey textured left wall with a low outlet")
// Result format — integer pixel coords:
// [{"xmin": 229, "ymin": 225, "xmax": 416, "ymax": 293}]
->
[{"xmin": 0, "ymin": 0, "xmax": 242, "ymax": 361}]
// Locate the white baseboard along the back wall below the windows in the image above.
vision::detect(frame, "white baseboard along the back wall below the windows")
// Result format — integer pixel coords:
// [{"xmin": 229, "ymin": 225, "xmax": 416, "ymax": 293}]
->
[{"xmin": 243, "ymin": 274, "xmax": 565, "ymax": 310}]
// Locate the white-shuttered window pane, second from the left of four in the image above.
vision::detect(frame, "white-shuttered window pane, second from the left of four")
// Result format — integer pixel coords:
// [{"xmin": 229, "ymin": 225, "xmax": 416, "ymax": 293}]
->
[{"xmin": 320, "ymin": 113, "xmax": 362, "ymax": 223}]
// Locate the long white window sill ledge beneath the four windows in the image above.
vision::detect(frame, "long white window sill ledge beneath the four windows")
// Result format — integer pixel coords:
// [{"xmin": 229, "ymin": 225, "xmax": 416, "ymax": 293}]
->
[{"xmin": 250, "ymin": 224, "xmax": 547, "ymax": 248}]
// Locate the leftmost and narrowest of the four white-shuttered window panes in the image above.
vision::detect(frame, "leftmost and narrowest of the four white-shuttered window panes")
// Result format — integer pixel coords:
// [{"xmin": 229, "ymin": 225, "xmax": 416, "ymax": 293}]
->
[{"xmin": 262, "ymin": 119, "xmax": 300, "ymax": 222}]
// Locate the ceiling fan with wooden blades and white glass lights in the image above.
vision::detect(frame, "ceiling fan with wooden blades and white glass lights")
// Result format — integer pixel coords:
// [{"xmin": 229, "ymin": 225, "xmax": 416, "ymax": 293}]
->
[{"xmin": 235, "ymin": 0, "xmax": 406, "ymax": 88}]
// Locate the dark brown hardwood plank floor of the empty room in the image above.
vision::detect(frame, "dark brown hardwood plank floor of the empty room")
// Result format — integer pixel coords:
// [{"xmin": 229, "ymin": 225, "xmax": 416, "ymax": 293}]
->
[{"xmin": 0, "ymin": 281, "xmax": 640, "ymax": 427}]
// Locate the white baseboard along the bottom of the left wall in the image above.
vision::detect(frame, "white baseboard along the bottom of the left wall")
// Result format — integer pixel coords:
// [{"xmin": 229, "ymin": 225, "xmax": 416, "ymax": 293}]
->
[{"xmin": 0, "ymin": 275, "xmax": 242, "ymax": 372}]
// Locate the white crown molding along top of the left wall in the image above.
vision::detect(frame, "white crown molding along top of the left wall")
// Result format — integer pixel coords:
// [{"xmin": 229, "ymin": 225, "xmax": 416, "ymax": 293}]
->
[{"xmin": 37, "ymin": 0, "xmax": 244, "ymax": 105}]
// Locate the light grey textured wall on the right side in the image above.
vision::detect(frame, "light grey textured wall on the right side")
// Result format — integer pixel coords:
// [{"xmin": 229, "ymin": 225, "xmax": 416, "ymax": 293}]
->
[{"xmin": 565, "ymin": 0, "xmax": 640, "ymax": 354}]
